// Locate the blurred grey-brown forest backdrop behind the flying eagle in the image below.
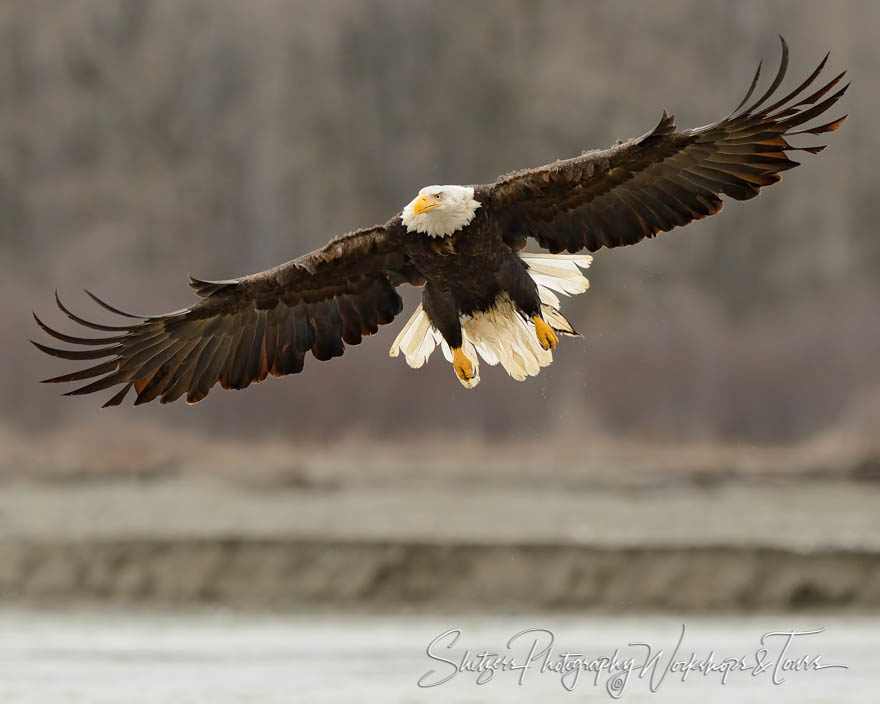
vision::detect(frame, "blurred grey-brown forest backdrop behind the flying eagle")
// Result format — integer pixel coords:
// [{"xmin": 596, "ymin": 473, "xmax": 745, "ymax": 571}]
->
[{"xmin": 0, "ymin": 0, "xmax": 880, "ymax": 468}]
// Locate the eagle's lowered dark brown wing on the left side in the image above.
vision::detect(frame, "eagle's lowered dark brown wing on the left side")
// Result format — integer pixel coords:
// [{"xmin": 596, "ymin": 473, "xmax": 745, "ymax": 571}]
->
[{"xmin": 34, "ymin": 220, "xmax": 424, "ymax": 406}]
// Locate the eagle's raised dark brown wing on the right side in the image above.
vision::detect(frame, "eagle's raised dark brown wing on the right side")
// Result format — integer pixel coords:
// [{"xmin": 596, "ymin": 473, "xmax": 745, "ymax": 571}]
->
[{"xmin": 492, "ymin": 37, "xmax": 849, "ymax": 253}]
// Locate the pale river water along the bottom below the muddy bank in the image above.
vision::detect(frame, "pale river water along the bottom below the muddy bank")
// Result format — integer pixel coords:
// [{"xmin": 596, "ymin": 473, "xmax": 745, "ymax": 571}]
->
[{"xmin": 0, "ymin": 608, "xmax": 880, "ymax": 704}]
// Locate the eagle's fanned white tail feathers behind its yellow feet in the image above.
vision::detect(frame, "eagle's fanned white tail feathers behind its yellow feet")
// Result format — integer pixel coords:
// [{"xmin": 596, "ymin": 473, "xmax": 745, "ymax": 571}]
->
[{"xmin": 390, "ymin": 254, "xmax": 593, "ymax": 389}]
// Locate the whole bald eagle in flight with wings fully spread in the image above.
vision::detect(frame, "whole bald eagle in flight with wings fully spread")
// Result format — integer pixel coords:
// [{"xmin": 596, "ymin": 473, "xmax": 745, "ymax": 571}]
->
[{"xmin": 34, "ymin": 37, "xmax": 849, "ymax": 406}]
